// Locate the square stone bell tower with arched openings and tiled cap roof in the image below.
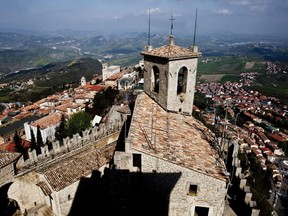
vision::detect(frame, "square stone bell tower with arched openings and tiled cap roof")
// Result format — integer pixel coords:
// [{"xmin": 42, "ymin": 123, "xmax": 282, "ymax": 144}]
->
[{"xmin": 141, "ymin": 35, "xmax": 201, "ymax": 115}]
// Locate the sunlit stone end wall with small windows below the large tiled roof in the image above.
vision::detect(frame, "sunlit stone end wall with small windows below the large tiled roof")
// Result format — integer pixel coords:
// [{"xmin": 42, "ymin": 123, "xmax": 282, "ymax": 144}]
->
[{"xmin": 141, "ymin": 154, "xmax": 227, "ymax": 216}]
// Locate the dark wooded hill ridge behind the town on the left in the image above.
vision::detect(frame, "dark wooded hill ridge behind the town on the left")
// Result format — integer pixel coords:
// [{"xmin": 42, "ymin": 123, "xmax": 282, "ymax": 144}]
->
[{"xmin": 0, "ymin": 58, "xmax": 102, "ymax": 102}]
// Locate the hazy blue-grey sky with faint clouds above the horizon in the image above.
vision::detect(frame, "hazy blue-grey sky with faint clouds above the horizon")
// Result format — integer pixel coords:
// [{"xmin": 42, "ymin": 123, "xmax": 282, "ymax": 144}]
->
[{"xmin": 0, "ymin": 0, "xmax": 288, "ymax": 36}]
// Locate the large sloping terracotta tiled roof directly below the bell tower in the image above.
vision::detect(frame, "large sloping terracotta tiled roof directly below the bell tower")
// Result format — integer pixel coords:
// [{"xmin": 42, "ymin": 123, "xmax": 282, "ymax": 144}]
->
[{"xmin": 128, "ymin": 93, "xmax": 225, "ymax": 179}]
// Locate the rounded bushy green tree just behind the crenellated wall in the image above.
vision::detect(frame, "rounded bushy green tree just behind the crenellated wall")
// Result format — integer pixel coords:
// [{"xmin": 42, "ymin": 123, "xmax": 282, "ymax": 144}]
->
[{"xmin": 66, "ymin": 111, "xmax": 92, "ymax": 137}]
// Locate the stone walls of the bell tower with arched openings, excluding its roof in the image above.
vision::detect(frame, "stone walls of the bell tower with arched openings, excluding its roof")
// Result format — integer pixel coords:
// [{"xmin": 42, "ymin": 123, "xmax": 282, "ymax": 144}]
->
[{"xmin": 144, "ymin": 56, "xmax": 198, "ymax": 115}]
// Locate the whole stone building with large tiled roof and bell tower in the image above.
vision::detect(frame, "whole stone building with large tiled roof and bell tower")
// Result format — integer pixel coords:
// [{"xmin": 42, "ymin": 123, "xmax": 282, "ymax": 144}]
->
[{"xmin": 111, "ymin": 35, "xmax": 228, "ymax": 216}]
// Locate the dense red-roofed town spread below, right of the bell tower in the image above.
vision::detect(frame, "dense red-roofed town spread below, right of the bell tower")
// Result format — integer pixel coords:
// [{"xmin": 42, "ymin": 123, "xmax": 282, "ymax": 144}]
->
[{"xmin": 194, "ymin": 66, "xmax": 288, "ymax": 213}]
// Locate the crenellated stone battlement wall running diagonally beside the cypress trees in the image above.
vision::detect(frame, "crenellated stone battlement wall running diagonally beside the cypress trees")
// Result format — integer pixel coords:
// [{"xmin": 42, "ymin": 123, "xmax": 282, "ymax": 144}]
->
[{"xmin": 16, "ymin": 114, "xmax": 126, "ymax": 175}]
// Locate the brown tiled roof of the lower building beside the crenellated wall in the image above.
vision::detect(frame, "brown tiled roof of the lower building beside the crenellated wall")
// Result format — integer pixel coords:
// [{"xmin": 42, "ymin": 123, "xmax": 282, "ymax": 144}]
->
[{"xmin": 39, "ymin": 144, "xmax": 116, "ymax": 191}]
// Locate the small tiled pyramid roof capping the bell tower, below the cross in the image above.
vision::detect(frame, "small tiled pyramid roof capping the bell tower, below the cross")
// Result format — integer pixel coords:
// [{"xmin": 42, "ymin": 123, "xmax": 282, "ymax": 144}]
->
[{"xmin": 141, "ymin": 35, "xmax": 201, "ymax": 60}]
